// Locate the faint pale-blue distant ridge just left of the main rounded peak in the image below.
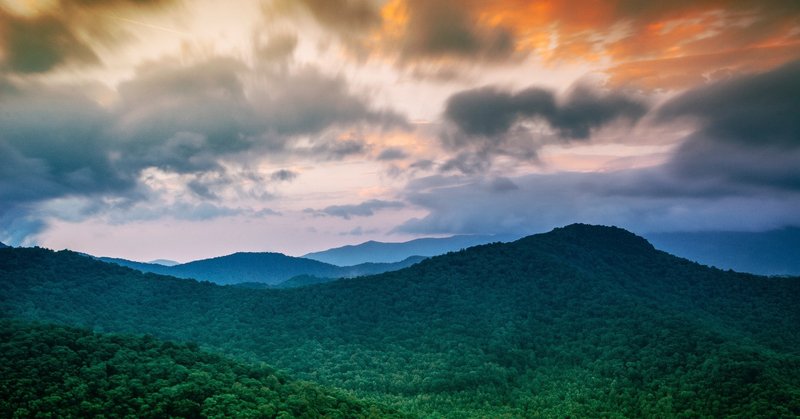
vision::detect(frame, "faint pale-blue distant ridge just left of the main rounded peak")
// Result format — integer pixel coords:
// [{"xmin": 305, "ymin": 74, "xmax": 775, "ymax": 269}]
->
[{"xmin": 303, "ymin": 235, "xmax": 519, "ymax": 266}]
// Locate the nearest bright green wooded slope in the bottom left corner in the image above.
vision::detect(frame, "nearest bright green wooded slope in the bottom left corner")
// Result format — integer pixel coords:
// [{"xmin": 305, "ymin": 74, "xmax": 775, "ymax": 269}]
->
[{"xmin": 0, "ymin": 321, "xmax": 397, "ymax": 418}]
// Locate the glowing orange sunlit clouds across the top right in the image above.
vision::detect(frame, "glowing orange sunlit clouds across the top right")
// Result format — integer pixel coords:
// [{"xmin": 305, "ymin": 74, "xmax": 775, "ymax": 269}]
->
[{"xmin": 360, "ymin": 0, "xmax": 800, "ymax": 87}]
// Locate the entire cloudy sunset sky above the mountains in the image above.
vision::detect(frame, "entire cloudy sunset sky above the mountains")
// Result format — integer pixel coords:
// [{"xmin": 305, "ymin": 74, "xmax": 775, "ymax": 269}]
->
[{"xmin": 0, "ymin": 0, "xmax": 800, "ymax": 261}]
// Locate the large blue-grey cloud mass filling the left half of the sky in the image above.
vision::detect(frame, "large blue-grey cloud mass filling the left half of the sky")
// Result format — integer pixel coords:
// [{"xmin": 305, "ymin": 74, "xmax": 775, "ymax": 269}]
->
[{"xmin": 0, "ymin": 58, "xmax": 405, "ymax": 243}]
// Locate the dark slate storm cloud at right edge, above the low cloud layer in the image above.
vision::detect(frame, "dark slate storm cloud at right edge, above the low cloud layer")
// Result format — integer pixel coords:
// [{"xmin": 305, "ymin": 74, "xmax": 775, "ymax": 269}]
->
[{"xmin": 658, "ymin": 62, "xmax": 800, "ymax": 191}]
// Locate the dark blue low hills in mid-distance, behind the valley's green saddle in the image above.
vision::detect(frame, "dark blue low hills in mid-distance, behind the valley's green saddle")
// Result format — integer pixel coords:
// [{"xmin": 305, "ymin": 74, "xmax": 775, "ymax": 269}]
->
[{"xmin": 98, "ymin": 252, "xmax": 424, "ymax": 285}]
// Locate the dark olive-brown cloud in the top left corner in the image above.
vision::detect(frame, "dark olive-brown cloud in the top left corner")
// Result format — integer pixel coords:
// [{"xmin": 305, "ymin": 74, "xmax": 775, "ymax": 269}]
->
[{"xmin": 0, "ymin": 0, "xmax": 174, "ymax": 73}]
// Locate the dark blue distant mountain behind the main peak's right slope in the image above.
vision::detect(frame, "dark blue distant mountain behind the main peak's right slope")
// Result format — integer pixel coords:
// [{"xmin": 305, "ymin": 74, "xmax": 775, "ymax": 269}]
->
[{"xmin": 647, "ymin": 227, "xmax": 800, "ymax": 275}]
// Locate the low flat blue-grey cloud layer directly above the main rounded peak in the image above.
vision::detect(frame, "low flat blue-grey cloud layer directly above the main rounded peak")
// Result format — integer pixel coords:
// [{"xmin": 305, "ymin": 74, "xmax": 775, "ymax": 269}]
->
[{"xmin": 394, "ymin": 169, "xmax": 800, "ymax": 235}]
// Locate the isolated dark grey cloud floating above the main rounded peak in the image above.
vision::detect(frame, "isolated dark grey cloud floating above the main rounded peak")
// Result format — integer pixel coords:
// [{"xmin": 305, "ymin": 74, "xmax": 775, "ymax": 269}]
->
[{"xmin": 439, "ymin": 84, "xmax": 648, "ymax": 173}]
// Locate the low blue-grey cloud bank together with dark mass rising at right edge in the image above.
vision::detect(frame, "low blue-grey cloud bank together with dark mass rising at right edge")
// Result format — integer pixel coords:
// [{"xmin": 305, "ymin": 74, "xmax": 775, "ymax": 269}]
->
[{"xmin": 396, "ymin": 63, "xmax": 800, "ymax": 238}]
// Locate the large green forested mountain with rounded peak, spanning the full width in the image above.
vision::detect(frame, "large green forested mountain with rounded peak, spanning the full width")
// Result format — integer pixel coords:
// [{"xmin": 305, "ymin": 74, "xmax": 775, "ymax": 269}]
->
[{"xmin": 0, "ymin": 225, "xmax": 800, "ymax": 417}]
